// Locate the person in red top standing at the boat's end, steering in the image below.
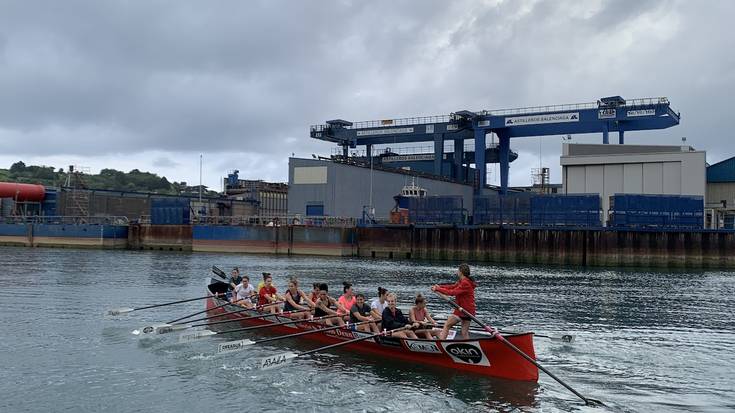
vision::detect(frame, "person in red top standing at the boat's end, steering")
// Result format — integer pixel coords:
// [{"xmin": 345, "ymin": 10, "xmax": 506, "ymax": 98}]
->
[{"xmin": 431, "ymin": 264, "xmax": 477, "ymax": 340}]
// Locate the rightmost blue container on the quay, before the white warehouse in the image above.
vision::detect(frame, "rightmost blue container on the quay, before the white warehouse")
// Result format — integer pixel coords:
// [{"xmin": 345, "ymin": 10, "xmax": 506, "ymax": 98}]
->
[{"xmin": 608, "ymin": 194, "xmax": 704, "ymax": 229}]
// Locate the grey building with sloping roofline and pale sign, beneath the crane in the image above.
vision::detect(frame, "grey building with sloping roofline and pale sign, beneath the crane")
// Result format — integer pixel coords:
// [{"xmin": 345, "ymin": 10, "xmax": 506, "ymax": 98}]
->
[{"xmin": 288, "ymin": 158, "xmax": 490, "ymax": 218}]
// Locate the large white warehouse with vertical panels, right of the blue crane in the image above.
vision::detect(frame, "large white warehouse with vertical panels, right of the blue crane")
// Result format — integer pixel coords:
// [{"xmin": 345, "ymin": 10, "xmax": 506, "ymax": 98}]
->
[{"xmin": 560, "ymin": 143, "xmax": 707, "ymax": 221}]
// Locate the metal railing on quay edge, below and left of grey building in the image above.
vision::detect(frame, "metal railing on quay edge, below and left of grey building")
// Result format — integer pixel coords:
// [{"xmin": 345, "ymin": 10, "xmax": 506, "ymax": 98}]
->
[{"xmin": 192, "ymin": 214, "xmax": 357, "ymax": 228}]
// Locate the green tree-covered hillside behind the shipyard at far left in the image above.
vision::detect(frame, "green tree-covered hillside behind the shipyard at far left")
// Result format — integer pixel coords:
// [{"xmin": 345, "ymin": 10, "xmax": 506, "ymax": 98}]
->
[{"xmin": 0, "ymin": 162, "xmax": 217, "ymax": 196}]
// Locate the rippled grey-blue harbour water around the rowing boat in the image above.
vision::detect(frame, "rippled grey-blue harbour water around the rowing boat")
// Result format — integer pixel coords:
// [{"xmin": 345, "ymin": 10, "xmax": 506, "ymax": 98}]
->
[{"xmin": 0, "ymin": 247, "xmax": 735, "ymax": 413}]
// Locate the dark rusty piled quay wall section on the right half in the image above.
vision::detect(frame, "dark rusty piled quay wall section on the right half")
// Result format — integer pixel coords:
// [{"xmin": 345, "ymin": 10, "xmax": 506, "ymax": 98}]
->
[{"xmin": 357, "ymin": 227, "xmax": 735, "ymax": 268}]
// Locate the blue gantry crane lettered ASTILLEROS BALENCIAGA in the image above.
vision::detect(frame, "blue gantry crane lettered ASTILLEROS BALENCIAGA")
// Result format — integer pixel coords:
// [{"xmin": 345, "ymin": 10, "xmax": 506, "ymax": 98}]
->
[{"xmin": 310, "ymin": 96, "xmax": 680, "ymax": 193}]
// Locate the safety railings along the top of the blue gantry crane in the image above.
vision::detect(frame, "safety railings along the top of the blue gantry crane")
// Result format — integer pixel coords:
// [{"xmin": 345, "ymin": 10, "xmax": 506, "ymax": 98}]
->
[{"xmin": 310, "ymin": 96, "xmax": 669, "ymax": 132}]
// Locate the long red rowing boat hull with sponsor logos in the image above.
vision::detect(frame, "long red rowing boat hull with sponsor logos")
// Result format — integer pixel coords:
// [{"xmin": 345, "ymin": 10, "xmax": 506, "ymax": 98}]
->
[{"xmin": 206, "ymin": 279, "xmax": 538, "ymax": 382}]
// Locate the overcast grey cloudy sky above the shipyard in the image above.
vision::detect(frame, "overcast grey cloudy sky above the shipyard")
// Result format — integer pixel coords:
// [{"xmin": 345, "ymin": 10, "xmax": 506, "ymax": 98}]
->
[{"xmin": 0, "ymin": 0, "xmax": 735, "ymax": 189}]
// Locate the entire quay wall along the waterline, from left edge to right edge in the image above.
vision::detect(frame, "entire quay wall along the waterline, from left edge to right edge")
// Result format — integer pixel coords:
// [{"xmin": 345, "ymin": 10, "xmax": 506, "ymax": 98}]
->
[{"xmin": 0, "ymin": 223, "xmax": 735, "ymax": 268}]
